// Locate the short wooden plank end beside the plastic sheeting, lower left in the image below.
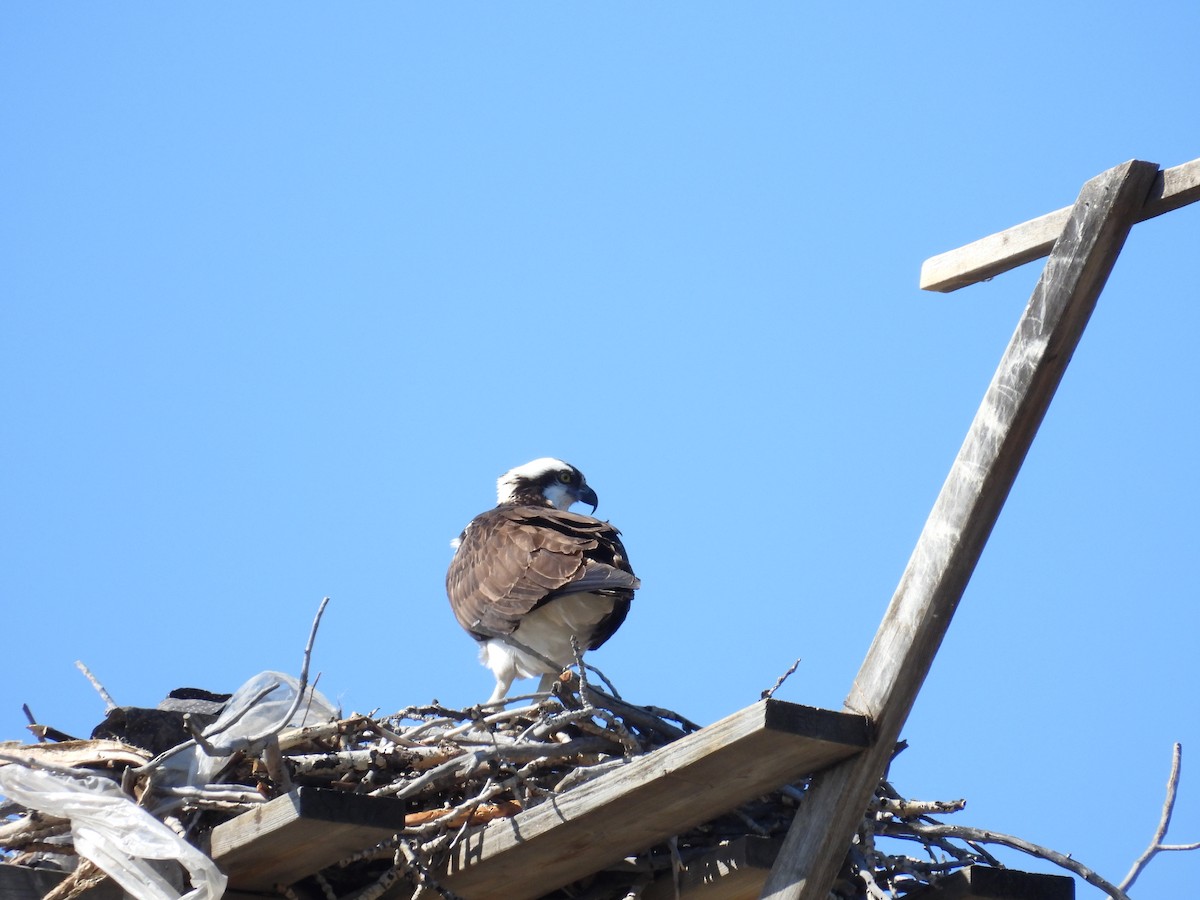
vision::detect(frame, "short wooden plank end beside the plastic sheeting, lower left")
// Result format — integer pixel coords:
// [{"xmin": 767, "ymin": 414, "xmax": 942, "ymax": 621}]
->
[{"xmin": 209, "ymin": 787, "xmax": 404, "ymax": 890}]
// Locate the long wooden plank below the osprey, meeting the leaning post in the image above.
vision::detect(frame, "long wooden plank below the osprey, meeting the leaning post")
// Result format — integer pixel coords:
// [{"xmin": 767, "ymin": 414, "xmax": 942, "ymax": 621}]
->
[{"xmin": 442, "ymin": 700, "xmax": 868, "ymax": 900}]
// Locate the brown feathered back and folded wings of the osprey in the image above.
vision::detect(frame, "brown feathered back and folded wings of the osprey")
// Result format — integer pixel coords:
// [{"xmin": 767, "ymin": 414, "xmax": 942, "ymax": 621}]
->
[{"xmin": 446, "ymin": 506, "xmax": 638, "ymax": 640}]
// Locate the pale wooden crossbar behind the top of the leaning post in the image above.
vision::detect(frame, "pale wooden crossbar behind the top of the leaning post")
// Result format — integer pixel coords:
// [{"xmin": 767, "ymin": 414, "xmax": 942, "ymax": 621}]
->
[{"xmin": 920, "ymin": 160, "xmax": 1200, "ymax": 293}]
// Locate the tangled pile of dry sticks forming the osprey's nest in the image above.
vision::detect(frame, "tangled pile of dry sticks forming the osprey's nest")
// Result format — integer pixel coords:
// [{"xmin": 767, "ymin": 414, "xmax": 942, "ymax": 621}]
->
[{"xmin": 0, "ymin": 676, "xmax": 1012, "ymax": 900}]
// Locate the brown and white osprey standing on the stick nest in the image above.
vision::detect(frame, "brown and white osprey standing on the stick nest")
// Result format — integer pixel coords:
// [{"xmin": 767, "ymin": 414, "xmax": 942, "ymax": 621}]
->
[{"xmin": 446, "ymin": 457, "xmax": 641, "ymax": 703}]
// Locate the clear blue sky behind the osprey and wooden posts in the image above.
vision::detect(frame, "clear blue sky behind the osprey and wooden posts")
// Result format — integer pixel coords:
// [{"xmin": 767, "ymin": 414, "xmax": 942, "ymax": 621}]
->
[{"xmin": 0, "ymin": 1, "xmax": 1200, "ymax": 898}]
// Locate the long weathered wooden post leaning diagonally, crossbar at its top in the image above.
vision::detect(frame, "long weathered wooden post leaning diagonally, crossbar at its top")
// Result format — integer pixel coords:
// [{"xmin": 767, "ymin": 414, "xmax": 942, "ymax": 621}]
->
[{"xmin": 763, "ymin": 161, "xmax": 1157, "ymax": 900}]
